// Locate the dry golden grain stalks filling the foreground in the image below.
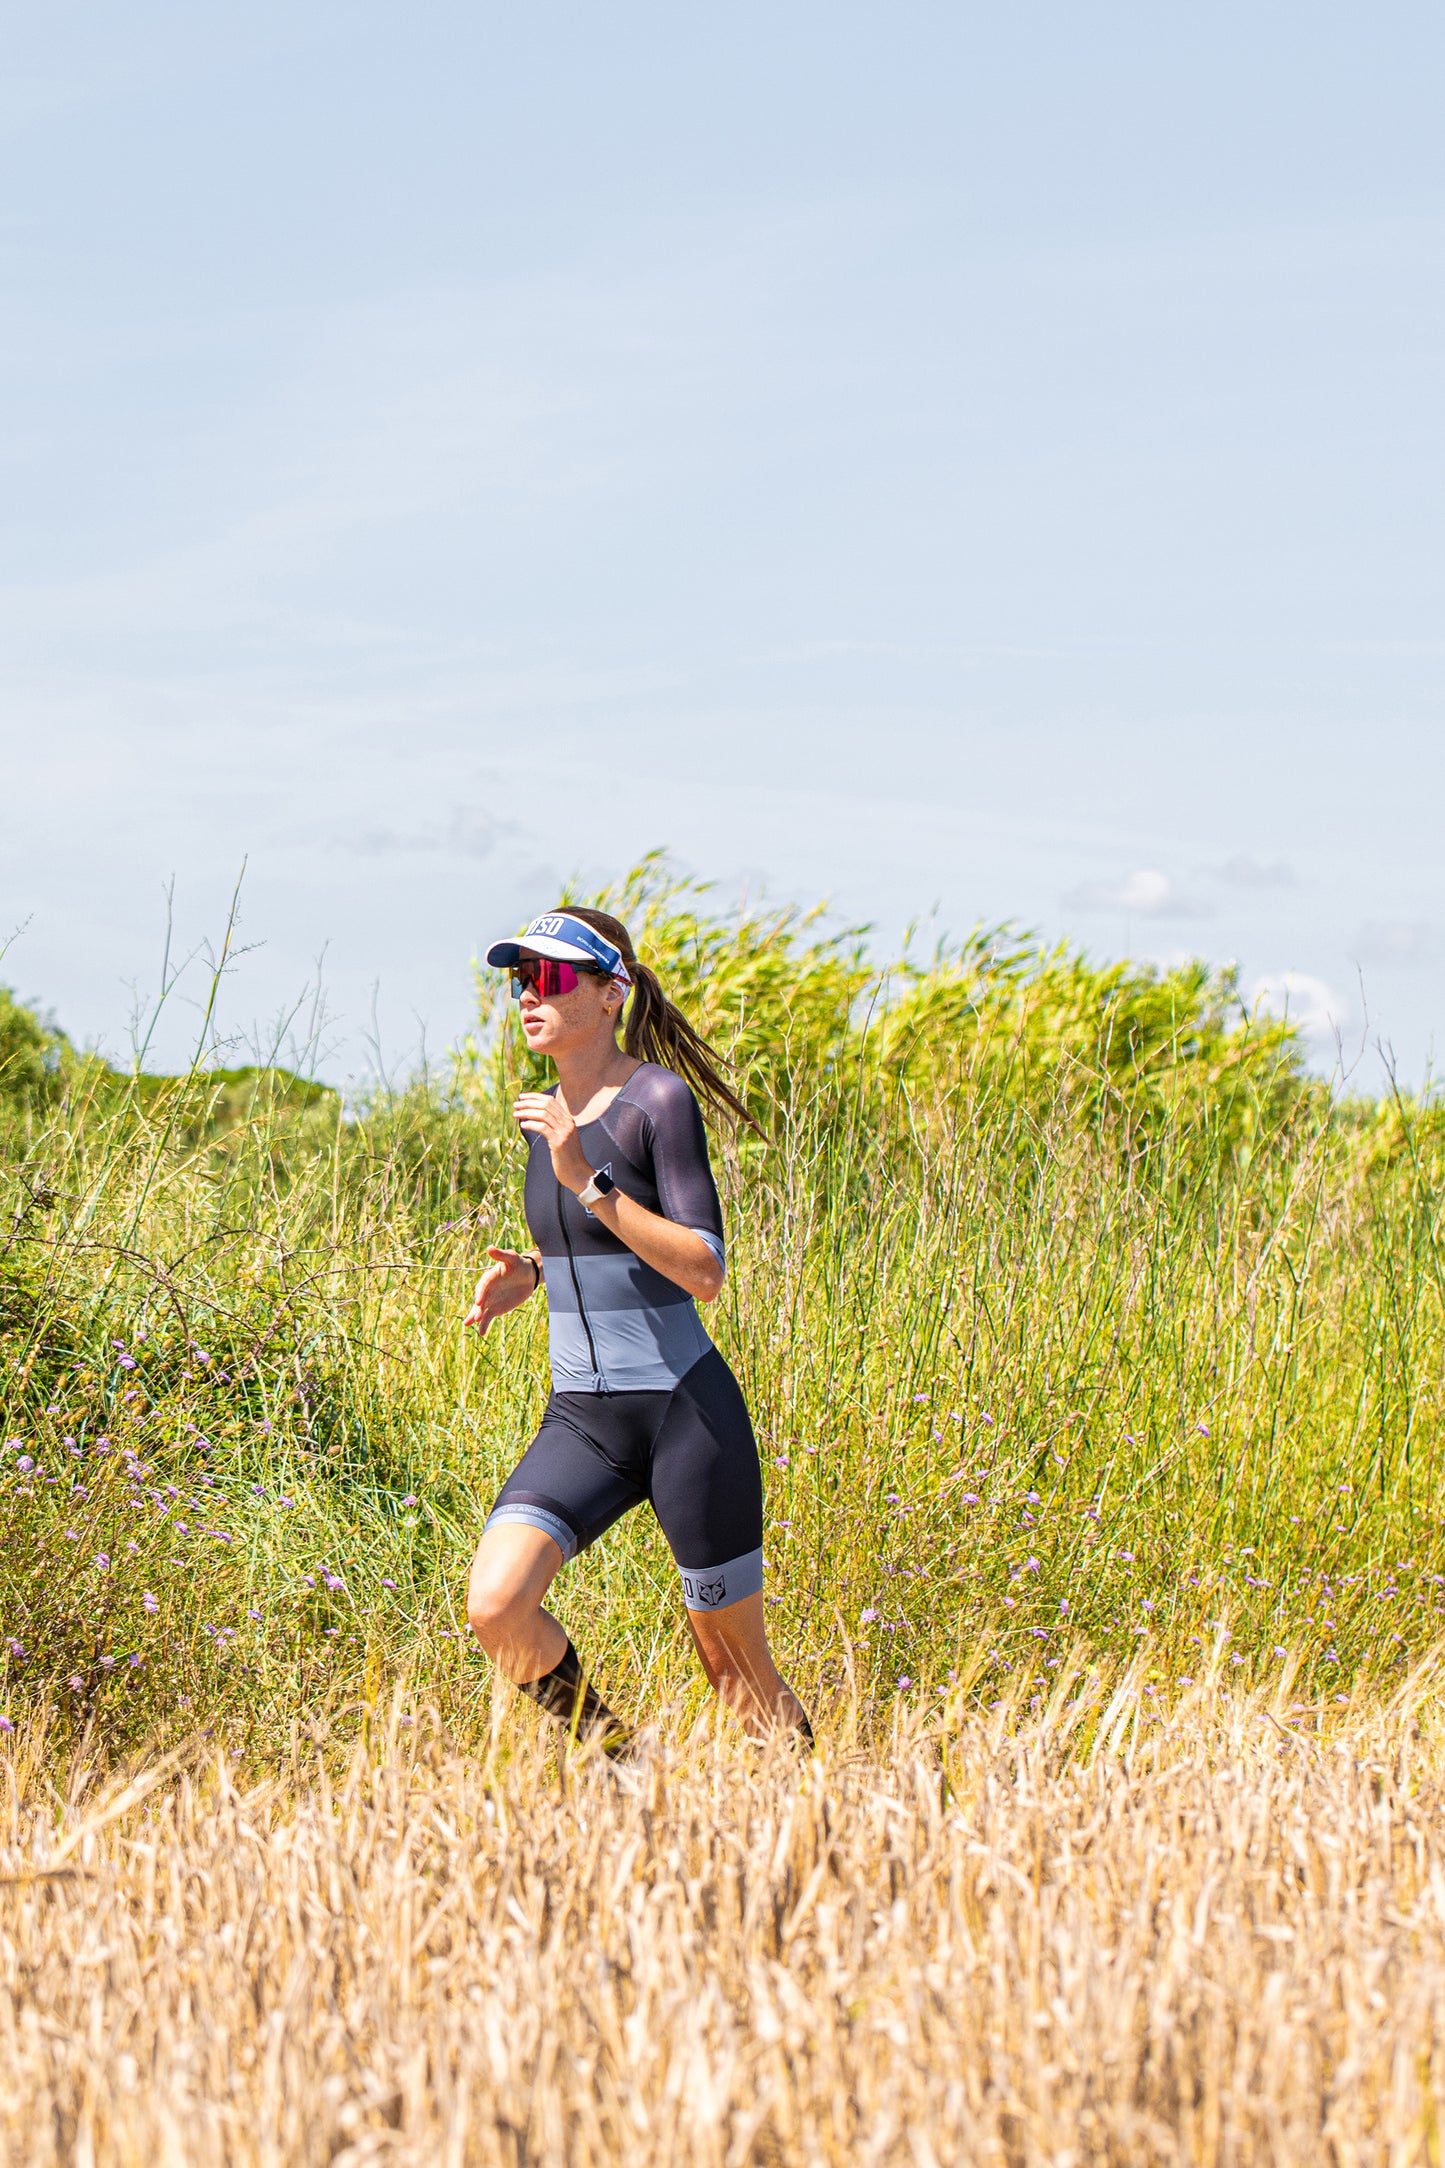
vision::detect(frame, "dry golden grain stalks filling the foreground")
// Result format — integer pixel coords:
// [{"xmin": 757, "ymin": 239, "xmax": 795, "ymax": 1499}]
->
[{"xmin": 0, "ymin": 1682, "xmax": 1445, "ymax": 2168}]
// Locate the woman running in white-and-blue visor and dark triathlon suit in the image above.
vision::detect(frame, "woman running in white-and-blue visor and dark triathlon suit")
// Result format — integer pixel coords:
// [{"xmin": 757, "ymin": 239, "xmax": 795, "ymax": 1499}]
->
[{"xmin": 466, "ymin": 904, "xmax": 812, "ymax": 1754}]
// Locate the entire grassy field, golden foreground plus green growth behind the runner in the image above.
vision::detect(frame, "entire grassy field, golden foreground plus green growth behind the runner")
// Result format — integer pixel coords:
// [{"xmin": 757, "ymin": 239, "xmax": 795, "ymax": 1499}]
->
[{"xmin": 0, "ymin": 861, "xmax": 1445, "ymax": 2161}]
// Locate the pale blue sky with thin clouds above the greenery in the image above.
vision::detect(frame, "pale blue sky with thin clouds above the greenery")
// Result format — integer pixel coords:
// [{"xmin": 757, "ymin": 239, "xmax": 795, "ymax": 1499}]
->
[{"xmin": 0, "ymin": 0, "xmax": 1445, "ymax": 1082}]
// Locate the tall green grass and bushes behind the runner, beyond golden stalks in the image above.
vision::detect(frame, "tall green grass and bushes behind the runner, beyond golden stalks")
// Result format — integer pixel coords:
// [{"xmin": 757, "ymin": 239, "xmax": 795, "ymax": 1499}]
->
[{"xmin": 0, "ymin": 861, "xmax": 1445, "ymax": 1750}]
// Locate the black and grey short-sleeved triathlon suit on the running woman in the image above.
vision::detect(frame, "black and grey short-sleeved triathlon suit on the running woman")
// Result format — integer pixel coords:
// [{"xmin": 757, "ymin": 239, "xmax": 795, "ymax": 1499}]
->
[{"xmin": 487, "ymin": 1062, "xmax": 763, "ymax": 1611}]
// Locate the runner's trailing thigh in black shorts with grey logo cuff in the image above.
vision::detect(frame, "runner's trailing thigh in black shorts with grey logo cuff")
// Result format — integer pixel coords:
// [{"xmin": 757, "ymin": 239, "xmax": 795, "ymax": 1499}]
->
[{"xmin": 652, "ymin": 1348, "xmax": 763, "ymax": 1613}]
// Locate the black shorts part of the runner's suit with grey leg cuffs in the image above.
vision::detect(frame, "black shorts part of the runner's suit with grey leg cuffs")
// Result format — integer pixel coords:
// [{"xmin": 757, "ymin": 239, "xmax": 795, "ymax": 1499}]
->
[{"xmin": 487, "ymin": 1348, "xmax": 763, "ymax": 1611}]
